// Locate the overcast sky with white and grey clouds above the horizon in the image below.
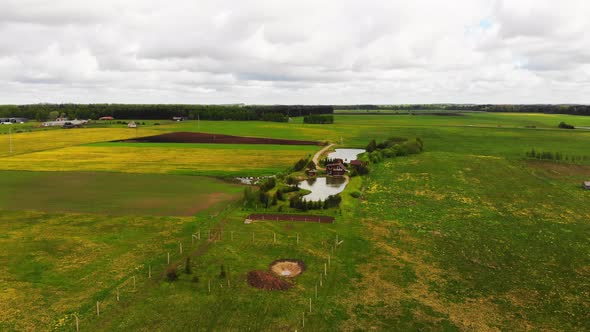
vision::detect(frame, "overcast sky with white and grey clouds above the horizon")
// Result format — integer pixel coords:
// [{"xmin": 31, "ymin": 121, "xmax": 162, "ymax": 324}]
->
[{"xmin": 0, "ymin": 0, "xmax": 590, "ymax": 104}]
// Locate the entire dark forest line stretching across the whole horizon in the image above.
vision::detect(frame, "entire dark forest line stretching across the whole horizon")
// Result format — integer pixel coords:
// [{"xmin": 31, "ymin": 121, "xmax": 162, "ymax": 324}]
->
[{"xmin": 0, "ymin": 104, "xmax": 590, "ymax": 122}]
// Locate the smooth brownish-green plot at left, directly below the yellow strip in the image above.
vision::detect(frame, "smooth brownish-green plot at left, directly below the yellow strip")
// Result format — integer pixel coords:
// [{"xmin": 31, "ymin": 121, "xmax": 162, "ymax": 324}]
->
[{"xmin": 0, "ymin": 171, "xmax": 243, "ymax": 216}]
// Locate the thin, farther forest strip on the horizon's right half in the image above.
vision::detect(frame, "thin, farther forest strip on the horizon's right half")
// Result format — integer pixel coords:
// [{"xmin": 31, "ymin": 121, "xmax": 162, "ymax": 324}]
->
[{"xmin": 334, "ymin": 104, "xmax": 590, "ymax": 115}]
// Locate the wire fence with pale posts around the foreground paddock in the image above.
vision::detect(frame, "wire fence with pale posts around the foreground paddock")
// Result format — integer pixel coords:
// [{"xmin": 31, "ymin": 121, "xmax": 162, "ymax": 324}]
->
[{"xmin": 54, "ymin": 224, "xmax": 344, "ymax": 331}]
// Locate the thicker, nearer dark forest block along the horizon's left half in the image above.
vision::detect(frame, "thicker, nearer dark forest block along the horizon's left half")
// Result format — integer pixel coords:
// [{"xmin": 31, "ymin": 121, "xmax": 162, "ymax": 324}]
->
[{"xmin": 0, "ymin": 104, "xmax": 334, "ymax": 122}]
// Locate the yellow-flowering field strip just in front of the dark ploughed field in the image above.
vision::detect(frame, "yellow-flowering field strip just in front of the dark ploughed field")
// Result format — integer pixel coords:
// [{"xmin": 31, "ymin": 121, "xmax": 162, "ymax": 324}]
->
[{"xmin": 0, "ymin": 144, "xmax": 319, "ymax": 175}]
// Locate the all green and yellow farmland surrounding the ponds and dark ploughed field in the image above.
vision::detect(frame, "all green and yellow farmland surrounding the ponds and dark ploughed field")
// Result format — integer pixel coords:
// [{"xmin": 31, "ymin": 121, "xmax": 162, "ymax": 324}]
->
[{"xmin": 0, "ymin": 113, "xmax": 590, "ymax": 331}]
